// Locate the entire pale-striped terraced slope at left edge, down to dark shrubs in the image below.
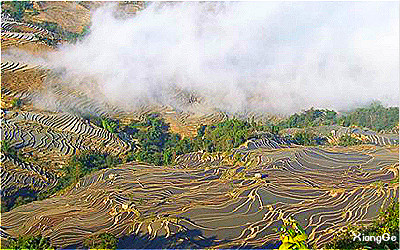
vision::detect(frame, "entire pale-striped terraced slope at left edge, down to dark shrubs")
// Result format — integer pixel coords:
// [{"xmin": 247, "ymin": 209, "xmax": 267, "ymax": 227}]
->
[{"xmin": 1, "ymin": 111, "xmax": 130, "ymax": 203}]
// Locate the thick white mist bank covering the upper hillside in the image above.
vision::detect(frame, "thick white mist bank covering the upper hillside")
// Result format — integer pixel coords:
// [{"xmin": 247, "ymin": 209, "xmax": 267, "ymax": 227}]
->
[{"xmin": 47, "ymin": 2, "xmax": 399, "ymax": 114}]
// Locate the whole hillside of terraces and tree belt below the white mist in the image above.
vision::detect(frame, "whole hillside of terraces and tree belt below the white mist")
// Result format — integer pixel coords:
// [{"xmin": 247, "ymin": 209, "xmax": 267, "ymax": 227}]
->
[{"xmin": 0, "ymin": 1, "xmax": 399, "ymax": 249}]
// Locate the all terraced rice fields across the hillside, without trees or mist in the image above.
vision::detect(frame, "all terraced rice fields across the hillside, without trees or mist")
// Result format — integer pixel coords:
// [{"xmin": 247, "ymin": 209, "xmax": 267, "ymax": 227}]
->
[{"xmin": 0, "ymin": 2, "xmax": 399, "ymax": 248}]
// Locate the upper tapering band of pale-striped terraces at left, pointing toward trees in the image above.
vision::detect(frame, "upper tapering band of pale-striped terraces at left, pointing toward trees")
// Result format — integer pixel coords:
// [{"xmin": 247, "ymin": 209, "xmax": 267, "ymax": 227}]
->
[{"xmin": 2, "ymin": 111, "xmax": 129, "ymax": 155}]
